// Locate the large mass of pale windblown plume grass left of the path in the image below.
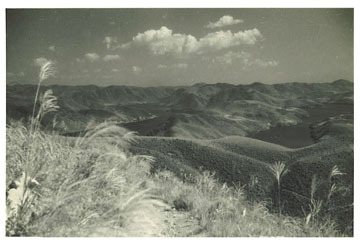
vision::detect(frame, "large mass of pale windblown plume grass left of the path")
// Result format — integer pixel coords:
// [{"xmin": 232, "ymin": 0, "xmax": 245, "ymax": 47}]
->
[{"xmin": 6, "ymin": 62, "xmax": 157, "ymax": 236}]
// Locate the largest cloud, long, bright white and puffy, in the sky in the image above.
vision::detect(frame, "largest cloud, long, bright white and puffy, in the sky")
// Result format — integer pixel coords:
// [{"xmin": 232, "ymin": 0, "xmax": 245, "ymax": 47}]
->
[{"xmin": 121, "ymin": 26, "xmax": 262, "ymax": 55}]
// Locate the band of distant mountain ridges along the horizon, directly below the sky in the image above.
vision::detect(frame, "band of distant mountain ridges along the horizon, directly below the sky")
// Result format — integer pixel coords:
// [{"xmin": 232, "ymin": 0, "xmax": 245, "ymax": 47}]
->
[{"xmin": 6, "ymin": 80, "xmax": 354, "ymax": 138}]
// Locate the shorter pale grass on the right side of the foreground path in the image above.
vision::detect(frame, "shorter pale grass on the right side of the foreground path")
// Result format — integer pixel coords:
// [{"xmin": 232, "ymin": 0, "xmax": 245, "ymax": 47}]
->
[{"xmin": 155, "ymin": 171, "xmax": 340, "ymax": 237}]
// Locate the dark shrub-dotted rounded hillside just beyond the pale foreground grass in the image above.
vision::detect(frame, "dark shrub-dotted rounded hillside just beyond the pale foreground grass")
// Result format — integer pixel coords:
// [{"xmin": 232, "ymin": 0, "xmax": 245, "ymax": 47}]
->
[{"xmin": 130, "ymin": 119, "xmax": 354, "ymax": 234}]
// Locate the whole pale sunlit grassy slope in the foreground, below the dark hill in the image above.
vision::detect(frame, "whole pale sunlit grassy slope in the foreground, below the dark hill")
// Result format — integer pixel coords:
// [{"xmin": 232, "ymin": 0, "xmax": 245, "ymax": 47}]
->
[{"xmin": 6, "ymin": 123, "xmax": 346, "ymax": 237}]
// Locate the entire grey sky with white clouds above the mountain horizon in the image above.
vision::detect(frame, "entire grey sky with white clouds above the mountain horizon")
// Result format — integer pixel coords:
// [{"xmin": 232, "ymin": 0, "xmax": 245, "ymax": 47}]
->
[{"xmin": 6, "ymin": 8, "xmax": 354, "ymax": 87}]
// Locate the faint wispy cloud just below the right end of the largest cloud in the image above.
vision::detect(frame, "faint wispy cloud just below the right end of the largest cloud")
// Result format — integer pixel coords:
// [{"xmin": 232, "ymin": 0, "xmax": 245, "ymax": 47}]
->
[{"xmin": 216, "ymin": 51, "xmax": 279, "ymax": 69}]
